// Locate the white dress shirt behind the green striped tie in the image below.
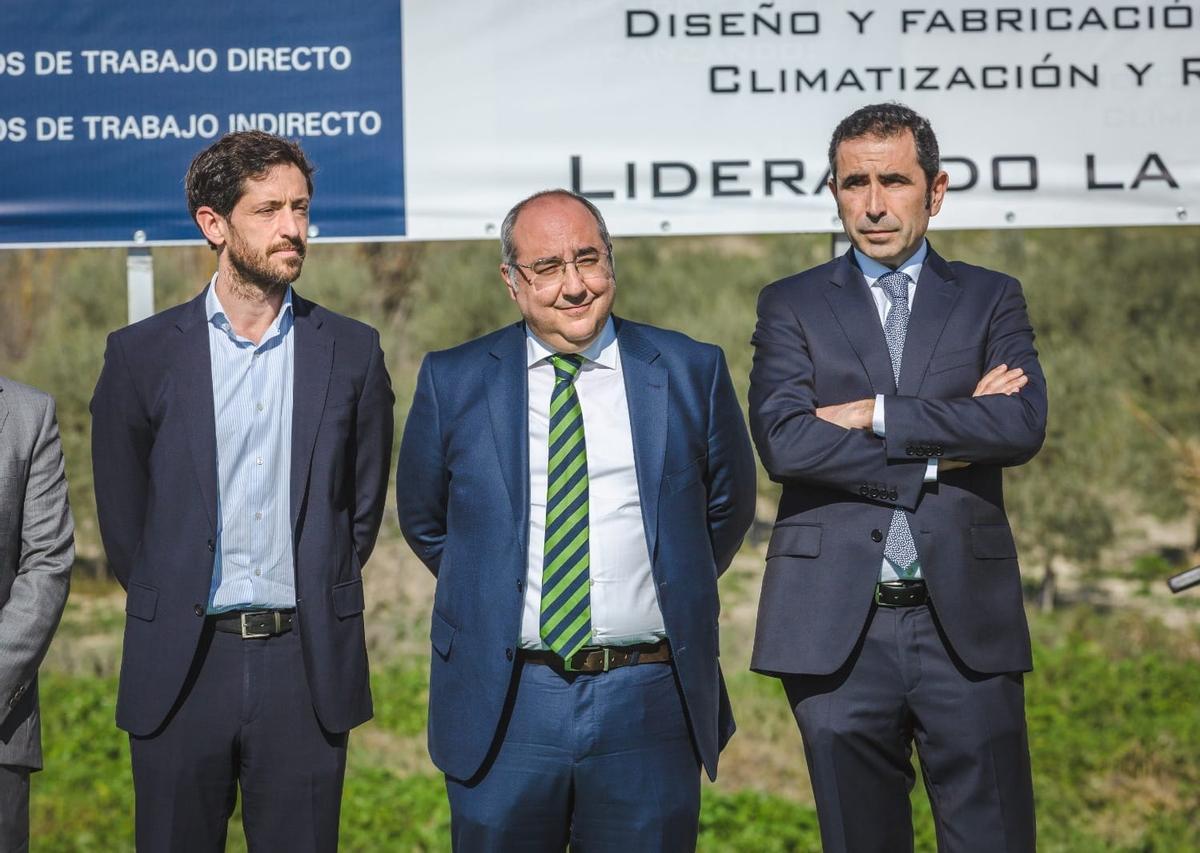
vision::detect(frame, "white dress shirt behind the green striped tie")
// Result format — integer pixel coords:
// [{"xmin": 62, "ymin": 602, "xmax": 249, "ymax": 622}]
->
[{"xmin": 521, "ymin": 318, "xmax": 666, "ymax": 649}]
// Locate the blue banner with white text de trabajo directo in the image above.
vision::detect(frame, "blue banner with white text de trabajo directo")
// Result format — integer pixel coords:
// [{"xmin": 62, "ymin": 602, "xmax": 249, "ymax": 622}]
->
[{"xmin": 0, "ymin": 0, "xmax": 406, "ymax": 246}]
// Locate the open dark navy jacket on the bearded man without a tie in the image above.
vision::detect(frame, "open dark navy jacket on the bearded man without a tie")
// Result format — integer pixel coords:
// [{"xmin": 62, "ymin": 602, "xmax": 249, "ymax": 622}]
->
[{"xmin": 91, "ymin": 290, "xmax": 392, "ymax": 734}]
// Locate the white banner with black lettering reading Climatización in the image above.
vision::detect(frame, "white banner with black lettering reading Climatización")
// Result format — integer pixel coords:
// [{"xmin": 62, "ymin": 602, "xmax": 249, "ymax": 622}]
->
[{"xmin": 403, "ymin": 0, "xmax": 1200, "ymax": 239}]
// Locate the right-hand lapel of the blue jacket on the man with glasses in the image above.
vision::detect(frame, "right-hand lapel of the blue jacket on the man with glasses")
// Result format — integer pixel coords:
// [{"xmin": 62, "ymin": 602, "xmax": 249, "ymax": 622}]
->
[{"xmin": 617, "ymin": 320, "xmax": 670, "ymax": 563}]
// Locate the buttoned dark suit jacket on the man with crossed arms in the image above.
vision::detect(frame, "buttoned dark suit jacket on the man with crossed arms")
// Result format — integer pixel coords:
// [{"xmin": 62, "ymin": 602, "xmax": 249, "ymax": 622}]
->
[{"xmin": 750, "ymin": 248, "xmax": 1046, "ymax": 674}]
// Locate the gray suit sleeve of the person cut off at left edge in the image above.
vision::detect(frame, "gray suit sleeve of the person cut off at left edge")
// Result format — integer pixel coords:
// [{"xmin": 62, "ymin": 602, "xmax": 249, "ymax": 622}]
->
[{"xmin": 0, "ymin": 397, "xmax": 74, "ymax": 725}]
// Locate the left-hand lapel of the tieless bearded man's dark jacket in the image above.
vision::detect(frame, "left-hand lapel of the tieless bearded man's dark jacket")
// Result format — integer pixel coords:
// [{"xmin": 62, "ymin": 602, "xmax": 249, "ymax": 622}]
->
[{"xmin": 175, "ymin": 293, "xmax": 217, "ymax": 531}]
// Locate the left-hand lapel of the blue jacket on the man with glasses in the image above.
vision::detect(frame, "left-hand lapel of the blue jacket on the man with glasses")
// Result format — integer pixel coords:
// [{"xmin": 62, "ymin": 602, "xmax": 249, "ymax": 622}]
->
[{"xmin": 484, "ymin": 323, "xmax": 529, "ymax": 544}]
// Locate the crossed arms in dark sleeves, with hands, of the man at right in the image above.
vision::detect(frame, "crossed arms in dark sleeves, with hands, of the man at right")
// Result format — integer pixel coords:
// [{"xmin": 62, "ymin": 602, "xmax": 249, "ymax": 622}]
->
[{"xmin": 750, "ymin": 278, "xmax": 1046, "ymax": 510}]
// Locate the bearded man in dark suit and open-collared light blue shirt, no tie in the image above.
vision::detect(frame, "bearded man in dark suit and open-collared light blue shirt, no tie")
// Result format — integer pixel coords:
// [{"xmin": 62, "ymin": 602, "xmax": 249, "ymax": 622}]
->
[{"xmin": 91, "ymin": 131, "xmax": 392, "ymax": 853}]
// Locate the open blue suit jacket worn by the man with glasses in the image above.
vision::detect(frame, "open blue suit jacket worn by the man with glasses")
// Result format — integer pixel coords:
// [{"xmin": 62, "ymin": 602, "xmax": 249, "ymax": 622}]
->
[{"xmin": 396, "ymin": 320, "xmax": 755, "ymax": 779}]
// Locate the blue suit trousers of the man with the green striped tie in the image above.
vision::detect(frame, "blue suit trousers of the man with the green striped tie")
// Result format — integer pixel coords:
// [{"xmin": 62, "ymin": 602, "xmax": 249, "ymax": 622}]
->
[{"xmin": 446, "ymin": 663, "xmax": 700, "ymax": 853}]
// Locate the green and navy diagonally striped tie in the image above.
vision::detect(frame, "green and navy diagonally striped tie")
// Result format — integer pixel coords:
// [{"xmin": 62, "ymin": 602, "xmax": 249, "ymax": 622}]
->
[{"xmin": 541, "ymin": 355, "xmax": 592, "ymax": 668}]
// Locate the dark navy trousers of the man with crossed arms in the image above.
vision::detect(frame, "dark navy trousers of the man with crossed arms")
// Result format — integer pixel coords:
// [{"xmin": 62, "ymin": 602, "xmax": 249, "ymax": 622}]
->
[{"xmin": 784, "ymin": 606, "xmax": 1034, "ymax": 853}]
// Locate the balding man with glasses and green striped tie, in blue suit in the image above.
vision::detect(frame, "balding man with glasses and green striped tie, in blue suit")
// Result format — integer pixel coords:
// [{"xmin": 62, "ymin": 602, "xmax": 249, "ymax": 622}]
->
[{"xmin": 396, "ymin": 190, "xmax": 755, "ymax": 853}]
